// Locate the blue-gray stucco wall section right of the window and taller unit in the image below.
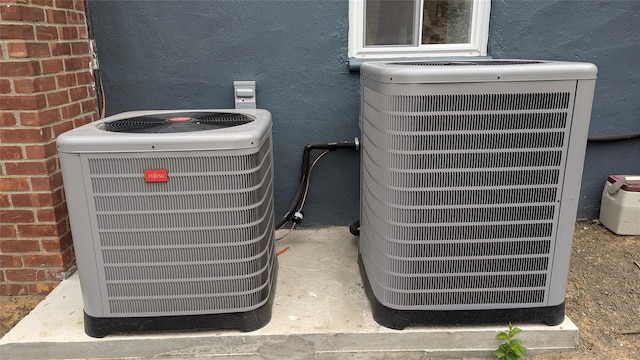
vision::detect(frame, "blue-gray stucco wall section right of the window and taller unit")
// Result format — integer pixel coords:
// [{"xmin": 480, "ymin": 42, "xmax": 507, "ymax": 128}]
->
[{"xmin": 489, "ymin": 0, "xmax": 640, "ymax": 218}]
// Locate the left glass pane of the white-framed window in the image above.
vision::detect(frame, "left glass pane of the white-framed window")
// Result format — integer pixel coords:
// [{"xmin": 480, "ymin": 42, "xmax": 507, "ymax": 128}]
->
[{"xmin": 365, "ymin": 0, "xmax": 415, "ymax": 45}]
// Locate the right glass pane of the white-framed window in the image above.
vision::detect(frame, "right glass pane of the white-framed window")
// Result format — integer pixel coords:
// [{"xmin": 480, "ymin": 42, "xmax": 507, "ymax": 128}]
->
[{"xmin": 422, "ymin": 0, "xmax": 473, "ymax": 44}]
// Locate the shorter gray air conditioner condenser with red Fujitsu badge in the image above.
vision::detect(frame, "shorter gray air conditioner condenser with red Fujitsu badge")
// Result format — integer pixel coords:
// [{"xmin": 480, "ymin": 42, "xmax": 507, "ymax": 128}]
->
[{"xmin": 57, "ymin": 110, "xmax": 277, "ymax": 337}]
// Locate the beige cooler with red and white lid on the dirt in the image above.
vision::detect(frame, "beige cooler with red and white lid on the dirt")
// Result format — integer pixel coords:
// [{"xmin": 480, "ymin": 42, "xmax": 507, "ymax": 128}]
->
[{"xmin": 600, "ymin": 175, "xmax": 640, "ymax": 235}]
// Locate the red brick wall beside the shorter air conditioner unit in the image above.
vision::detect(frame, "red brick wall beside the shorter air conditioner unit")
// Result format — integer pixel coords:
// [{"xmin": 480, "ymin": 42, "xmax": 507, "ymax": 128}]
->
[{"xmin": 0, "ymin": 0, "xmax": 98, "ymax": 295}]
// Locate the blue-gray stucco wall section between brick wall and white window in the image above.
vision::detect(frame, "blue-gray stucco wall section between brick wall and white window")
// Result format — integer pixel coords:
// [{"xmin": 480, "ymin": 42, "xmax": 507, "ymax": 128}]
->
[{"xmin": 89, "ymin": 0, "xmax": 360, "ymax": 225}]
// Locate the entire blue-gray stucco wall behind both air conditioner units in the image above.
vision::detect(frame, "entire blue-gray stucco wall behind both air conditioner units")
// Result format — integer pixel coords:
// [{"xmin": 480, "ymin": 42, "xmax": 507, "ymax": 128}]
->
[{"xmin": 89, "ymin": 0, "xmax": 640, "ymax": 225}]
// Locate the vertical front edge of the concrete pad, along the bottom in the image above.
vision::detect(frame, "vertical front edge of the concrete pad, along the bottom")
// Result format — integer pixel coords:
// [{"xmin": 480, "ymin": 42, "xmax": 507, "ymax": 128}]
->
[{"xmin": 0, "ymin": 329, "xmax": 578, "ymax": 360}]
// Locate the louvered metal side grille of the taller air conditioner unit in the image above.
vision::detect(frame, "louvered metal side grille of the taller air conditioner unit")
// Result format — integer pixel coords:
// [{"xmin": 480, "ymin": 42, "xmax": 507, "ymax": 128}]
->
[{"xmin": 360, "ymin": 80, "xmax": 575, "ymax": 310}]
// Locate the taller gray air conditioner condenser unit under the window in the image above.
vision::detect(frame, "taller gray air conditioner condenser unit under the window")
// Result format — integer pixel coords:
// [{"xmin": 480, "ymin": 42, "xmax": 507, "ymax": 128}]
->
[{"xmin": 359, "ymin": 60, "xmax": 597, "ymax": 329}]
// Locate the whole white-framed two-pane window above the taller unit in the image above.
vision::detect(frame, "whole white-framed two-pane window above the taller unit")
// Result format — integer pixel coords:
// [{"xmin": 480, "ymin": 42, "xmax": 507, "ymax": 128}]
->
[{"xmin": 349, "ymin": 0, "xmax": 491, "ymax": 59}]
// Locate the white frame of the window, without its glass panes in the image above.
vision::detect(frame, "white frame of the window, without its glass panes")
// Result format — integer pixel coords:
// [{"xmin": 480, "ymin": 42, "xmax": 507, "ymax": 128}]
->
[{"xmin": 348, "ymin": 0, "xmax": 491, "ymax": 59}]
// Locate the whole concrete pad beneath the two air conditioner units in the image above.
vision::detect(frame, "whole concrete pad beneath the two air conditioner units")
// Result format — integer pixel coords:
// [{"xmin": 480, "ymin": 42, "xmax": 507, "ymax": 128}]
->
[{"xmin": 0, "ymin": 227, "xmax": 578, "ymax": 360}]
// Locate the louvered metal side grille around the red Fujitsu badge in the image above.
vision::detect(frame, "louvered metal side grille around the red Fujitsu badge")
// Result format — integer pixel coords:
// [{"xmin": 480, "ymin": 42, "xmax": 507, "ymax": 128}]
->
[{"xmin": 86, "ymin": 138, "xmax": 275, "ymax": 316}]
